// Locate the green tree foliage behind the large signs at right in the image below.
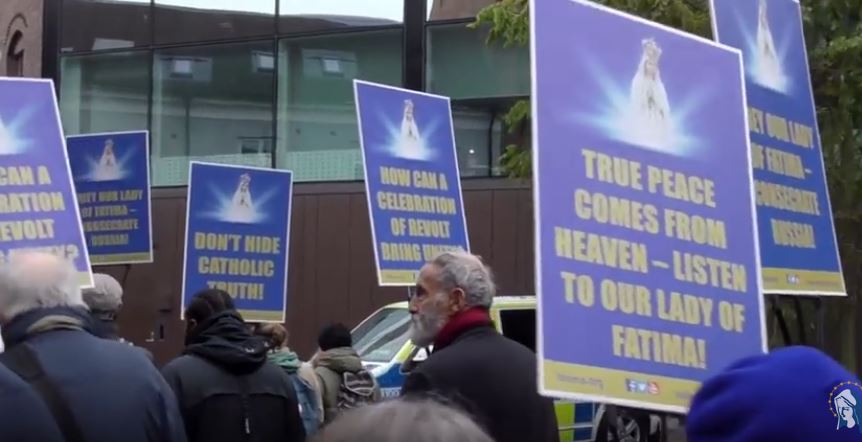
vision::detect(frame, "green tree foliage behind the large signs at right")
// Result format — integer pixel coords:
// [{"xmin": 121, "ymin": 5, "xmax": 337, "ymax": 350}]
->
[{"xmin": 471, "ymin": 0, "xmax": 862, "ymax": 365}]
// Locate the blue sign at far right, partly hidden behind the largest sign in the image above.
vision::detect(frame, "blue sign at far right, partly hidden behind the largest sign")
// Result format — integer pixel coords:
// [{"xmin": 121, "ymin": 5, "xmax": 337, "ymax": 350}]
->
[{"xmin": 711, "ymin": 0, "xmax": 847, "ymax": 296}]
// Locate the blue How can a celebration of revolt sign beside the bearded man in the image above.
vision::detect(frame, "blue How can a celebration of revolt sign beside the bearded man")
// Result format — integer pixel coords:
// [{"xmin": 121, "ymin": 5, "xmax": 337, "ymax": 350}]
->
[{"xmin": 353, "ymin": 80, "xmax": 470, "ymax": 286}]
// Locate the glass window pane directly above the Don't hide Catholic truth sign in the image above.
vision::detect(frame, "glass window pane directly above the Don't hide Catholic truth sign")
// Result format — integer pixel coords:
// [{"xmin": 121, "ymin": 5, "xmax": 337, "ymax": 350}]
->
[{"xmin": 151, "ymin": 41, "xmax": 275, "ymax": 186}]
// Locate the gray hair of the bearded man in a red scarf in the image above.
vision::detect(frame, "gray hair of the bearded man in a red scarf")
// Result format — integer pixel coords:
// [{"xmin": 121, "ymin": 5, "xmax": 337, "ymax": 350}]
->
[{"xmin": 431, "ymin": 250, "xmax": 497, "ymax": 307}]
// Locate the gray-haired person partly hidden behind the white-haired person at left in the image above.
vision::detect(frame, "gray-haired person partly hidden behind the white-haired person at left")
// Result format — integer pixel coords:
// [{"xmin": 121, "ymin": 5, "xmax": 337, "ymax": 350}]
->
[{"xmin": 82, "ymin": 273, "xmax": 153, "ymax": 361}]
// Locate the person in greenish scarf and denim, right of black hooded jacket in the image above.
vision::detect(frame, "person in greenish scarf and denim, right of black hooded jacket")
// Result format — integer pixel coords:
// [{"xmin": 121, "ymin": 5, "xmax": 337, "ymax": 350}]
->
[{"xmin": 254, "ymin": 324, "xmax": 323, "ymax": 436}]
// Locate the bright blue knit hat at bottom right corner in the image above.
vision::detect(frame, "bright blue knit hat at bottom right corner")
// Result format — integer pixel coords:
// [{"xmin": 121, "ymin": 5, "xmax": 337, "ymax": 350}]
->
[{"xmin": 686, "ymin": 347, "xmax": 862, "ymax": 442}]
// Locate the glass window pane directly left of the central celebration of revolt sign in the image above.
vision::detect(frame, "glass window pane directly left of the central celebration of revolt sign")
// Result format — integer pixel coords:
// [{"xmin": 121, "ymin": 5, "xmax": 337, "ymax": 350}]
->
[{"xmin": 276, "ymin": 29, "xmax": 402, "ymax": 181}]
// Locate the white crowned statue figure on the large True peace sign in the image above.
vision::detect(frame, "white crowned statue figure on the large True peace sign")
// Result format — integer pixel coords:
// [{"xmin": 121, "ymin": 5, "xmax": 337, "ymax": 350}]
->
[{"xmin": 629, "ymin": 64, "xmax": 673, "ymax": 148}]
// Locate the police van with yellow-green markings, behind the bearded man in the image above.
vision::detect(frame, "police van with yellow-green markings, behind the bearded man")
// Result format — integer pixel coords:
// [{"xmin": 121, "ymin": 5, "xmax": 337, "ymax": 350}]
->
[{"xmin": 353, "ymin": 296, "xmax": 662, "ymax": 442}]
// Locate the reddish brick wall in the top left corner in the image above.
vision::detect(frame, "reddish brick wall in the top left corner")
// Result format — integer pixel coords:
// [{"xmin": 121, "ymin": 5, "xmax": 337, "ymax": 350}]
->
[{"xmin": 0, "ymin": 0, "xmax": 43, "ymax": 77}]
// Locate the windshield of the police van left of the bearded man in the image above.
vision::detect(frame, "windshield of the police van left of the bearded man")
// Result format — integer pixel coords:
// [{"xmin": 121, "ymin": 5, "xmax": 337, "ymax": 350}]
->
[{"xmin": 353, "ymin": 308, "xmax": 410, "ymax": 363}]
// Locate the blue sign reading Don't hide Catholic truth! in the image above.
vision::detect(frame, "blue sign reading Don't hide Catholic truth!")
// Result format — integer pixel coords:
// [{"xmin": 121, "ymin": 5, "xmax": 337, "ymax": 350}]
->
[{"xmin": 182, "ymin": 161, "xmax": 293, "ymax": 322}]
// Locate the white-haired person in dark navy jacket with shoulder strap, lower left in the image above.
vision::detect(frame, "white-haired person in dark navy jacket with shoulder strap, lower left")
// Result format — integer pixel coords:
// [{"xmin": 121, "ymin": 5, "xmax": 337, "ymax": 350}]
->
[{"xmin": 0, "ymin": 252, "xmax": 186, "ymax": 442}]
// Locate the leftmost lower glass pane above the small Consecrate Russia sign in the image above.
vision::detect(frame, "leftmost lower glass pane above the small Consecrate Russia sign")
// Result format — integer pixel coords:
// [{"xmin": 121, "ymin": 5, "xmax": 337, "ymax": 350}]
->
[{"xmin": 60, "ymin": 51, "xmax": 150, "ymax": 135}]
